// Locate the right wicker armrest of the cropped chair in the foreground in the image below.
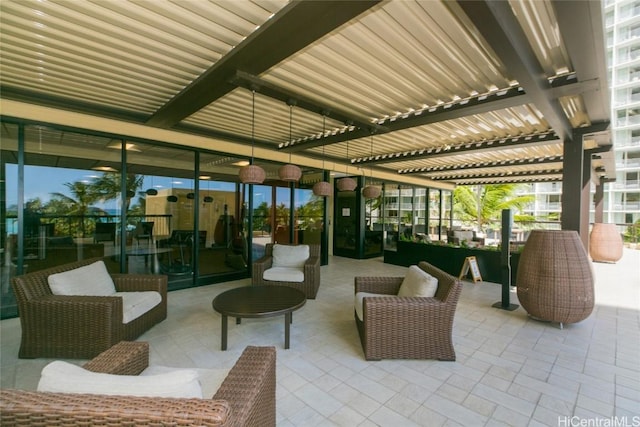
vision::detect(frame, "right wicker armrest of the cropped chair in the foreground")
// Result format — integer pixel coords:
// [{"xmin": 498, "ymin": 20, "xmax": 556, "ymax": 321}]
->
[{"xmin": 213, "ymin": 346, "xmax": 276, "ymax": 427}]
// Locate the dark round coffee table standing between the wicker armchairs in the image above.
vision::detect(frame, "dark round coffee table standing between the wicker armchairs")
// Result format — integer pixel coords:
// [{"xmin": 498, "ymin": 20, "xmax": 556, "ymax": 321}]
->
[{"xmin": 212, "ymin": 285, "xmax": 307, "ymax": 350}]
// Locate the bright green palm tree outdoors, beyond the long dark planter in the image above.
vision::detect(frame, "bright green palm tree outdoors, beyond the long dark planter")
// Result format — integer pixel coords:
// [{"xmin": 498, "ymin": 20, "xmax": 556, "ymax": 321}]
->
[{"xmin": 453, "ymin": 184, "xmax": 534, "ymax": 232}]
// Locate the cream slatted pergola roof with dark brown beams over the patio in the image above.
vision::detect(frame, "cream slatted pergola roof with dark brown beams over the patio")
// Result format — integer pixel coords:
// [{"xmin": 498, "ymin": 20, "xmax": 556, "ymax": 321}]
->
[{"xmin": 0, "ymin": 0, "xmax": 615, "ymax": 244}]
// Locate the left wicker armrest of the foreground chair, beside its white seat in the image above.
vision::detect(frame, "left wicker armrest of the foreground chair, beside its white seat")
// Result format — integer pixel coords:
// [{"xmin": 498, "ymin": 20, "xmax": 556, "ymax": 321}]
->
[{"xmin": 83, "ymin": 341, "xmax": 149, "ymax": 375}]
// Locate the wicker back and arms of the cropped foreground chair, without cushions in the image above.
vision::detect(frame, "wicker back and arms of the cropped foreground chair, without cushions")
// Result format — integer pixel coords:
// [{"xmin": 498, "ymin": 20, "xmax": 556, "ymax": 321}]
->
[{"xmin": 0, "ymin": 342, "xmax": 276, "ymax": 427}]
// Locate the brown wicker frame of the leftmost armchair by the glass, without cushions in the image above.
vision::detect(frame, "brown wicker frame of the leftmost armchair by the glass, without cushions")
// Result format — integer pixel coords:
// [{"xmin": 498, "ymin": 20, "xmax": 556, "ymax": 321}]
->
[{"xmin": 11, "ymin": 258, "xmax": 167, "ymax": 359}]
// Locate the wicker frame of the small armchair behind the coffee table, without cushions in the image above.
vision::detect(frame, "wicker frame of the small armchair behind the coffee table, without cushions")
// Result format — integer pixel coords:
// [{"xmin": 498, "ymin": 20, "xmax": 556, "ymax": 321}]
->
[{"xmin": 252, "ymin": 243, "xmax": 320, "ymax": 299}]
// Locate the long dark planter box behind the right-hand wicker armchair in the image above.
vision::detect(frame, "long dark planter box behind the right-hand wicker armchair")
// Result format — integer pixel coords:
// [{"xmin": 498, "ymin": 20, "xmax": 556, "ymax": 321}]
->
[{"xmin": 384, "ymin": 241, "xmax": 520, "ymax": 285}]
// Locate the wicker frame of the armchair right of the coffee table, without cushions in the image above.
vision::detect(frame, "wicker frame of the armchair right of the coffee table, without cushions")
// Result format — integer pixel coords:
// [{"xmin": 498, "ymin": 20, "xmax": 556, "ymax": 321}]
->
[{"xmin": 355, "ymin": 261, "xmax": 462, "ymax": 360}]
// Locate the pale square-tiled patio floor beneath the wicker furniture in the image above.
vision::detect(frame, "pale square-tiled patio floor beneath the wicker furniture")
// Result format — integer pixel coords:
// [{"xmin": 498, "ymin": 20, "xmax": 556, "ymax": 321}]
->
[{"xmin": 0, "ymin": 250, "xmax": 640, "ymax": 427}]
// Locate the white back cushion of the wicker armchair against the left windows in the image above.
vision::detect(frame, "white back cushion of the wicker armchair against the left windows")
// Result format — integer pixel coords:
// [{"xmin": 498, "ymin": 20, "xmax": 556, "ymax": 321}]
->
[{"xmin": 47, "ymin": 261, "xmax": 116, "ymax": 297}]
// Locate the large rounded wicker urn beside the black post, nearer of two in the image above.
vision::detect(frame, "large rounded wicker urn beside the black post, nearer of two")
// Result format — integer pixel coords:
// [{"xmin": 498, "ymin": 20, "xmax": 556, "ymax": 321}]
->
[{"xmin": 516, "ymin": 230, "xmax": 594, "ymax": 323}]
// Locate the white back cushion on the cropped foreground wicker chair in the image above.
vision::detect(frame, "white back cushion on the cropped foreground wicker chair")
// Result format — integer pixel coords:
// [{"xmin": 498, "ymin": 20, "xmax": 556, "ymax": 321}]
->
[{"xmin": 38, "ymin": 361, "xmax": 202, "ymax": 399}]
